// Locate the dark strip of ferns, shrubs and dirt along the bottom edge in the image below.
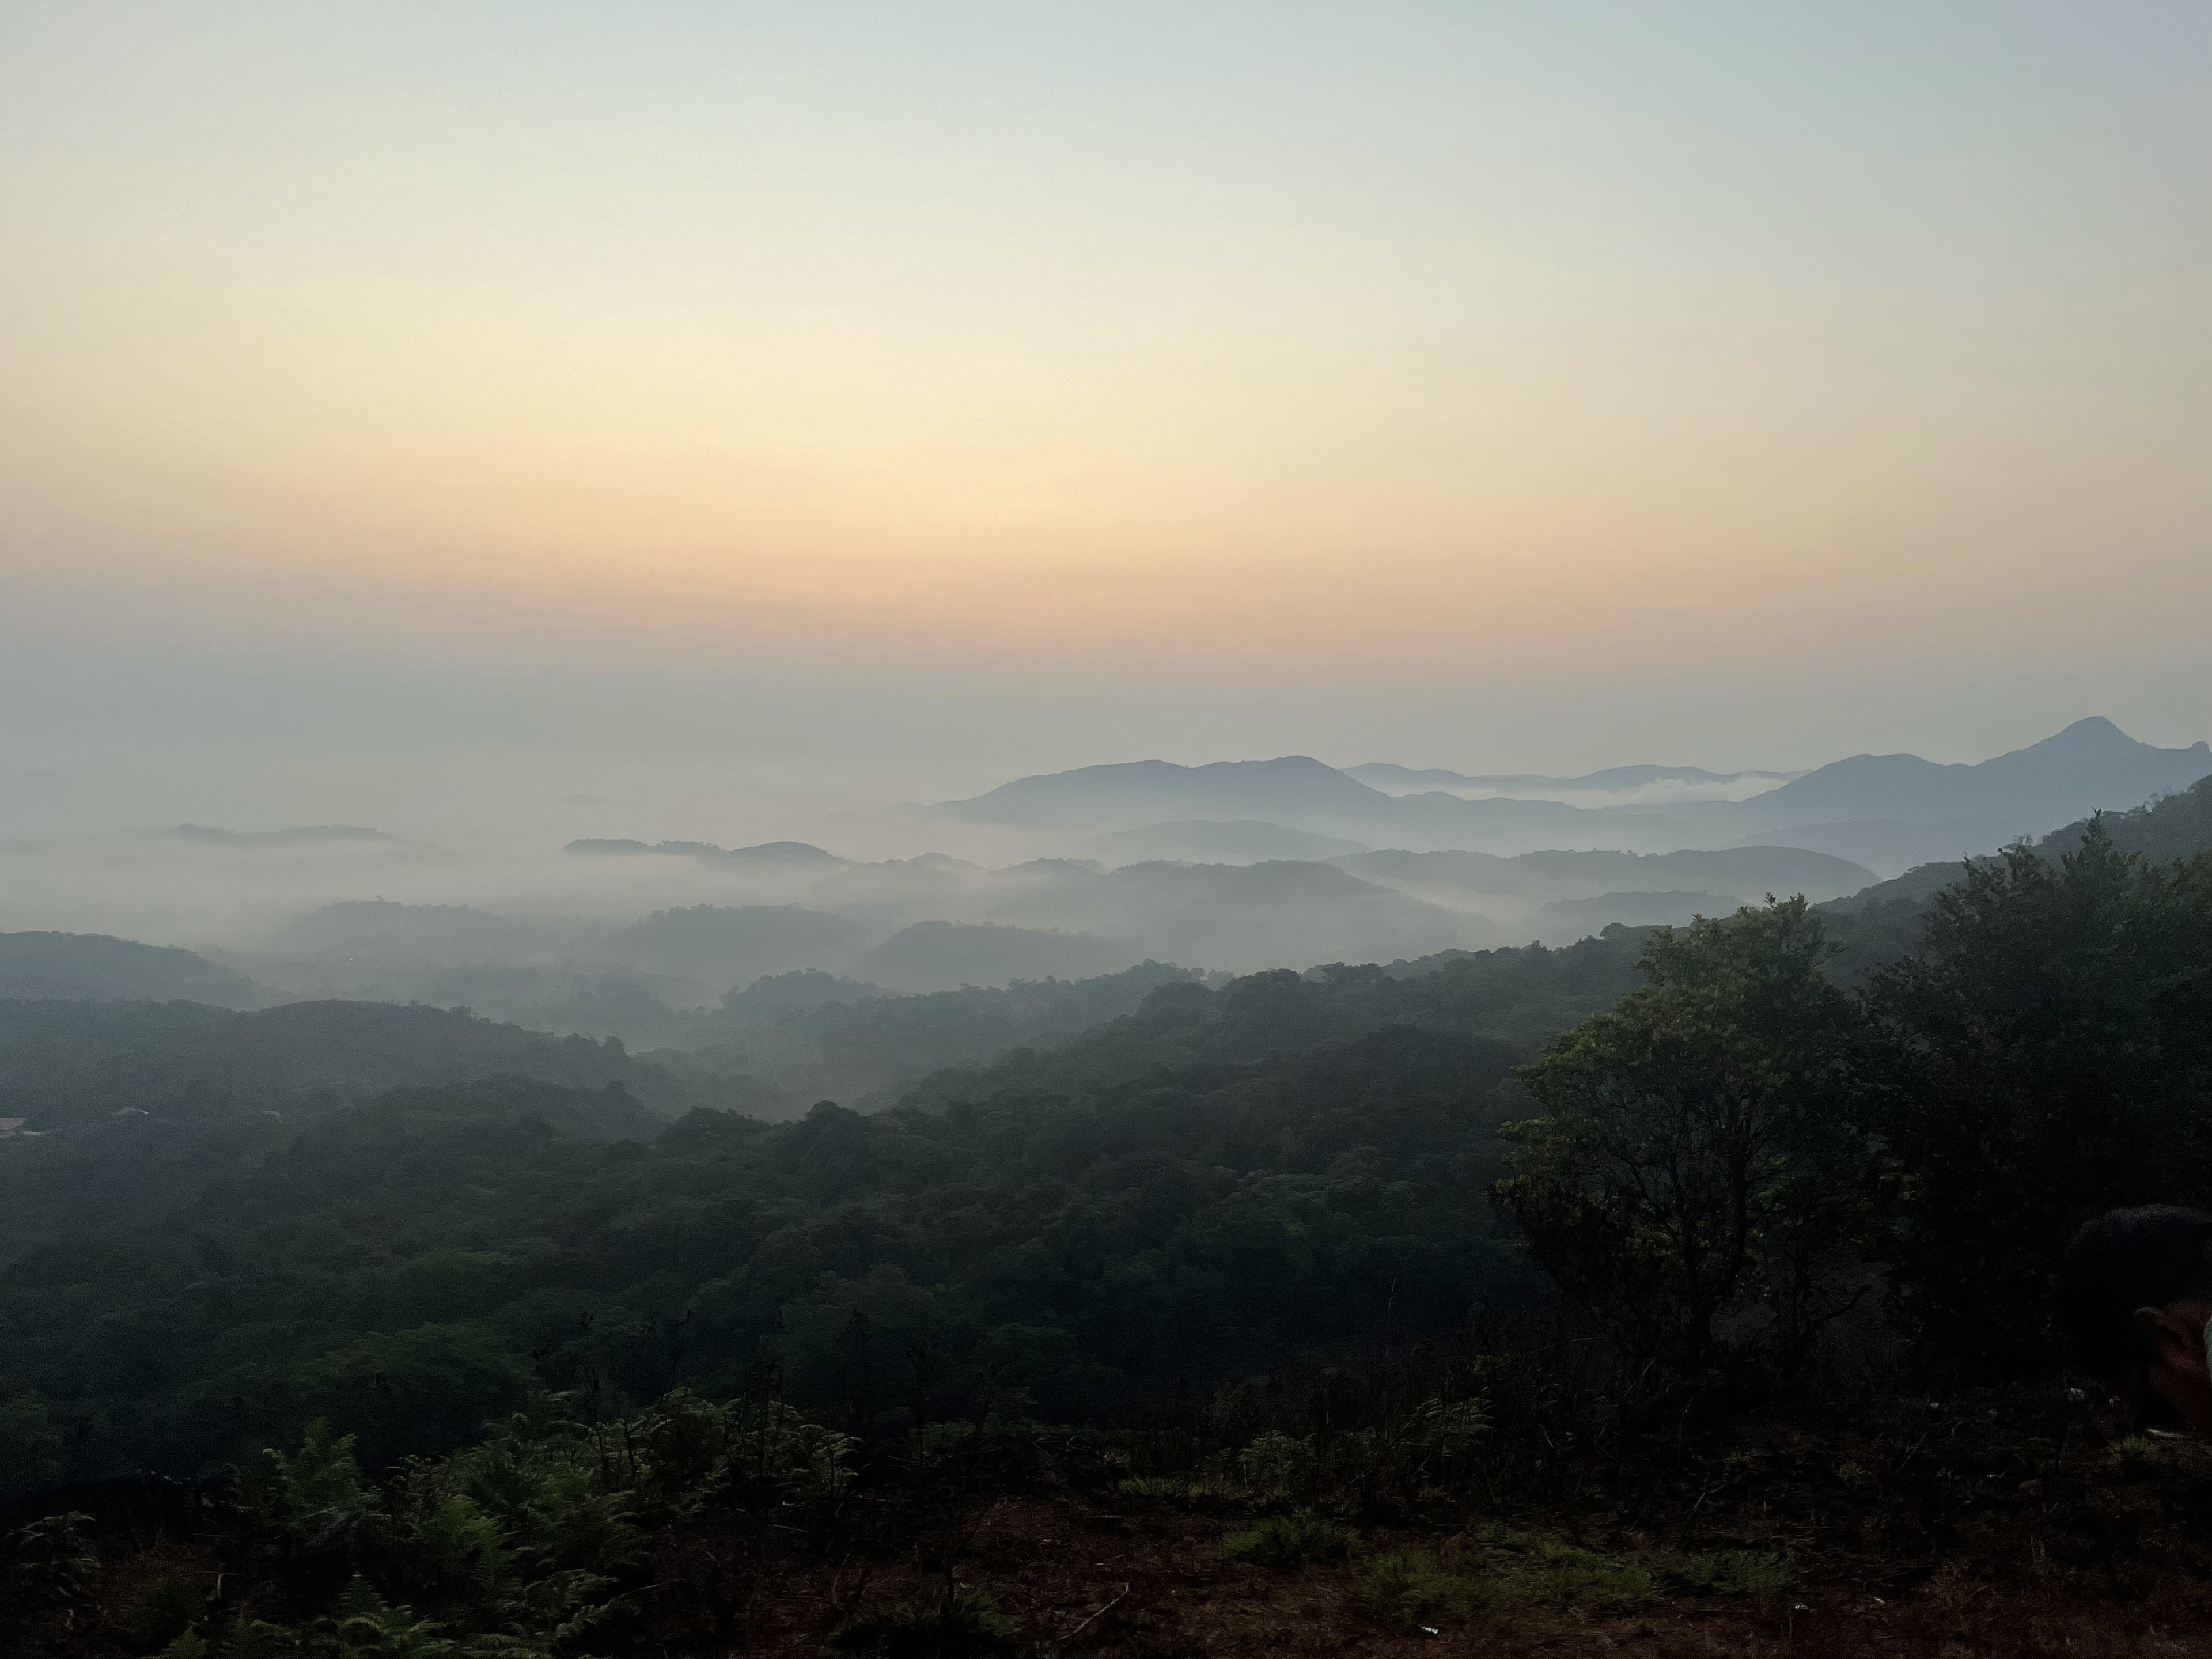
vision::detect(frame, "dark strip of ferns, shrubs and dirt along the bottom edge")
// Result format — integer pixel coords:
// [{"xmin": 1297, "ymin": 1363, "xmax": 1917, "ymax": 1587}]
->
[{"xmin": 0, "ymin": 1327, "xmax": 2212, "ymax": 1659}]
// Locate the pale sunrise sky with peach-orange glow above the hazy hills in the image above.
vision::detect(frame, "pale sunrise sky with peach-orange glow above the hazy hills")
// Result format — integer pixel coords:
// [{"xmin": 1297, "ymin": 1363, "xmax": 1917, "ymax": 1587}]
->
[{"xmin": 0, "ymin": 0, "xmax": 2212, "ymax": 819}]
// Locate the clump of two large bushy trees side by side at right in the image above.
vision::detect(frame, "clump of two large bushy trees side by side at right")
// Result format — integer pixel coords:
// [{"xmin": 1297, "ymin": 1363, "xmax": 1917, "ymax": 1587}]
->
[{"xmin": 1495, "ymin": 823, "xmax": 2212, "ymax": 1378}]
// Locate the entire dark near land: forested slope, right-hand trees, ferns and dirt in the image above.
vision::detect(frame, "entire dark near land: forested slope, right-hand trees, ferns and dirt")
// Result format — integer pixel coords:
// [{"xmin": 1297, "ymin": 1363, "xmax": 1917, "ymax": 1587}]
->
[{"xmin": 0, "ymin": 801, "xmax": 2212, "ymax": 1659}]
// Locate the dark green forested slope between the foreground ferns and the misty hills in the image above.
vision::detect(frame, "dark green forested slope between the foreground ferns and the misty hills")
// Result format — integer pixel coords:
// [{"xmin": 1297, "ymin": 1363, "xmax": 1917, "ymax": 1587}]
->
[{"xmin": 0, "ymin": 933, "xmax": 1637, "ymax": 1469}]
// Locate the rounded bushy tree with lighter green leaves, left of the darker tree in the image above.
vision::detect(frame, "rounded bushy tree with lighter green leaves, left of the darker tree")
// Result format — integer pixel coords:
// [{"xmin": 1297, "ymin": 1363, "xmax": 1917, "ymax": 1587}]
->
[{"xmin": 1493, "ymin": 898, "xmax": 1872, "ymax": 1372}]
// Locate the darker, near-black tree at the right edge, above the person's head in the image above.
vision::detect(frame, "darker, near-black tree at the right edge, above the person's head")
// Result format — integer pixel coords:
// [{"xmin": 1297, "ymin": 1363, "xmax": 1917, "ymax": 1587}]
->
[{"xmin": 1867, "ymin": 821, "xmax": 2212, "ymax": 1376}]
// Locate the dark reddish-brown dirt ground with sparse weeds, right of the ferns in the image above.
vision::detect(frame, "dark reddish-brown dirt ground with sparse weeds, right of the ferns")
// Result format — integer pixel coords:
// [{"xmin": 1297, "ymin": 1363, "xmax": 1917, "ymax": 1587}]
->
[{"xmin": 721, "ymin": 1385, "xmax": 2212, "ymax": 1659}]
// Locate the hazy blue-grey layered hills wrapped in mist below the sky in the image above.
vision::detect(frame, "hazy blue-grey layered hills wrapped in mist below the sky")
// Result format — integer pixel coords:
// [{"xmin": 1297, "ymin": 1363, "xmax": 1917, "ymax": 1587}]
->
[{"xmin": 116, "ymin": 719, "xmax": 2212, "ymax": 1046}]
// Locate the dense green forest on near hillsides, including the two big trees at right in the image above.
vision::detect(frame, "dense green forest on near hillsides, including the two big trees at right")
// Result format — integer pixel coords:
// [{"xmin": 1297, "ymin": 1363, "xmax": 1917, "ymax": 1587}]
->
[{"xmin": 0, "ymin": 791, "xmax": 2212, "ymax": 1521}]
